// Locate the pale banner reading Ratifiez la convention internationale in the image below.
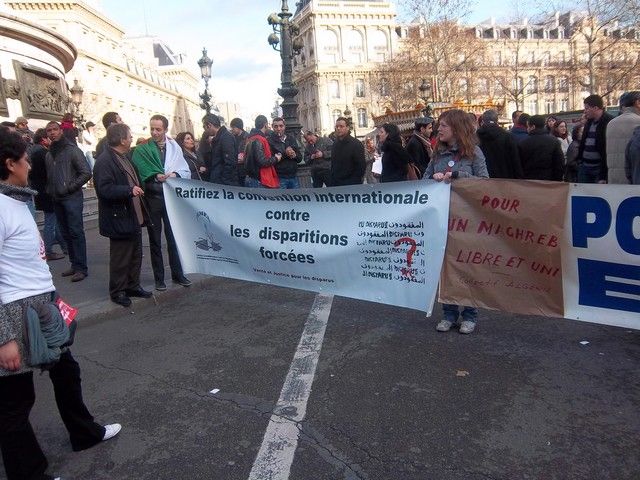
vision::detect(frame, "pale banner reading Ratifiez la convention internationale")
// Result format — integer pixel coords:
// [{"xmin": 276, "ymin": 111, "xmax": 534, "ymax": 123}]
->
[{"xmin": 164, "ymin": 179, "xmax": 450, "ymax": 314}]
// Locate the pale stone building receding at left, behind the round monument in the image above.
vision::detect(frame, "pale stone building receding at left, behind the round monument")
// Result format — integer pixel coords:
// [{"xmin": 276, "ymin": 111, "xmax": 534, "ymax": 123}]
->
[{"xmin": 4, "ymin": 0, "xmax": 203, "ymax": 136}]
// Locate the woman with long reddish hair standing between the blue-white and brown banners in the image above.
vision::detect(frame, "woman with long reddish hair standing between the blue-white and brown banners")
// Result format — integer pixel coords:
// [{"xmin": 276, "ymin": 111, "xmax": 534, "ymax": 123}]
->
[{"xmin": 424, "ymin": 110, "xmax": 489, "ymax": 333}]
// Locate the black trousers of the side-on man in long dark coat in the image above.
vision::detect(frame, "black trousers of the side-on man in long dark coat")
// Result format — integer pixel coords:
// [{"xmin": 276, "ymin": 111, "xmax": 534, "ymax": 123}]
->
[{"xmin": 109, "ymin": 232, "xmax": 142, "ymax": 298}]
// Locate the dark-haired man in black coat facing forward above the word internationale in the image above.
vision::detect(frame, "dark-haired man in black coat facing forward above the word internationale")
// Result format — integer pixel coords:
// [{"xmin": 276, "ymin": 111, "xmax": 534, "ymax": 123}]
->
[{"xmin": 331, "ymin": 117, "xmax": 367, "ymax": 187}]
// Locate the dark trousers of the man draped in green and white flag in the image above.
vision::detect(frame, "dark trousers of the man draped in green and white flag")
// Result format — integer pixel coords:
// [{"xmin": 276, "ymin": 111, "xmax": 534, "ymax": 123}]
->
[{"xmin": 145, "ymin": 192, "xmax": 183, "ymax": 282}]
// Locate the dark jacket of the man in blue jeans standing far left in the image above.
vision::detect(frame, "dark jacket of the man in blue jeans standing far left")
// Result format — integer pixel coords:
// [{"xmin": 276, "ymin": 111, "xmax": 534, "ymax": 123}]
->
[{"xmin": 45, "ymin": 137, "xmax": 91, "ymax": 200}]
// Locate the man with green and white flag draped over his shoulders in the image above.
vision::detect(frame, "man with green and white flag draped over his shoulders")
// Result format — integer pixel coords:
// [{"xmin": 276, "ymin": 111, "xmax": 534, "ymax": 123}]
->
[{"xmin": 131, "ymin": 115, "xmax": 191, "ymax": 291}]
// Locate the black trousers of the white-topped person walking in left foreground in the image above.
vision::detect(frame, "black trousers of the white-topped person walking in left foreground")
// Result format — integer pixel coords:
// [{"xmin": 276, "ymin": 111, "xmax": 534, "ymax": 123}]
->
[{"xmin": 0, "ymin": 351, "xmax": 105, "ymax": 480}]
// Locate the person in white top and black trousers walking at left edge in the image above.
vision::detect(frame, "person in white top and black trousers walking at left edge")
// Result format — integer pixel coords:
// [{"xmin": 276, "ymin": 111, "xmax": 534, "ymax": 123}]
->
[{"xmin": 0, "ymin": 131, "xmax": 121, "ymax": 480}]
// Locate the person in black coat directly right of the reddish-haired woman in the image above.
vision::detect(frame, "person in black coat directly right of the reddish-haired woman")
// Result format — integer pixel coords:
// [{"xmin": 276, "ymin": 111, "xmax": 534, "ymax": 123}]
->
[{"xmin": 477, "ymin": 110, "xmax": 523, "ymax": 178}]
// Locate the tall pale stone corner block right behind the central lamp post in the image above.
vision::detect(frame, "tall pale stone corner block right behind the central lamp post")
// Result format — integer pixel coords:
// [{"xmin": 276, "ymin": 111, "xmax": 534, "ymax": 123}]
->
[{"xmin": 293, "ymin": 0, "xmax": 398, "ymax": 135}]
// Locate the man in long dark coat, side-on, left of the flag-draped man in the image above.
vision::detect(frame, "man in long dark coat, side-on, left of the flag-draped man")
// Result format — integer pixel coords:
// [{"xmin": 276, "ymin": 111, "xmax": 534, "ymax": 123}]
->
[{"xmin": 93, "ymin": 123, "xmax": 151, "ymax": 307}]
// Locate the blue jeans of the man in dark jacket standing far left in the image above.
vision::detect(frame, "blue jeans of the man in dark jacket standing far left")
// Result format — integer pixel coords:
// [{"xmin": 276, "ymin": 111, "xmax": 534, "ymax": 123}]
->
[{"xmin": 54, "ymin": 190, "xmax": 88, "ymax": 275}]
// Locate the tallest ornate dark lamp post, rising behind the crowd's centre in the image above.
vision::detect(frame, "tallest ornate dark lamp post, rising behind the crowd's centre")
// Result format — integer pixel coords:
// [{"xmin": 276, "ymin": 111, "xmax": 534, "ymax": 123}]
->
[{"xmin": 267, "ymin": 0, "xmax": 304, "ymax": 138}]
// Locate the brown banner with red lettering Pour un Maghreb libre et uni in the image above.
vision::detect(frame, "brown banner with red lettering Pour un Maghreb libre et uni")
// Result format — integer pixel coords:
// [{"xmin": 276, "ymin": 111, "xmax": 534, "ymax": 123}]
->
[{"xmin": 438, "ymin": 179, "xmax": 569, "ymax": 317}]
